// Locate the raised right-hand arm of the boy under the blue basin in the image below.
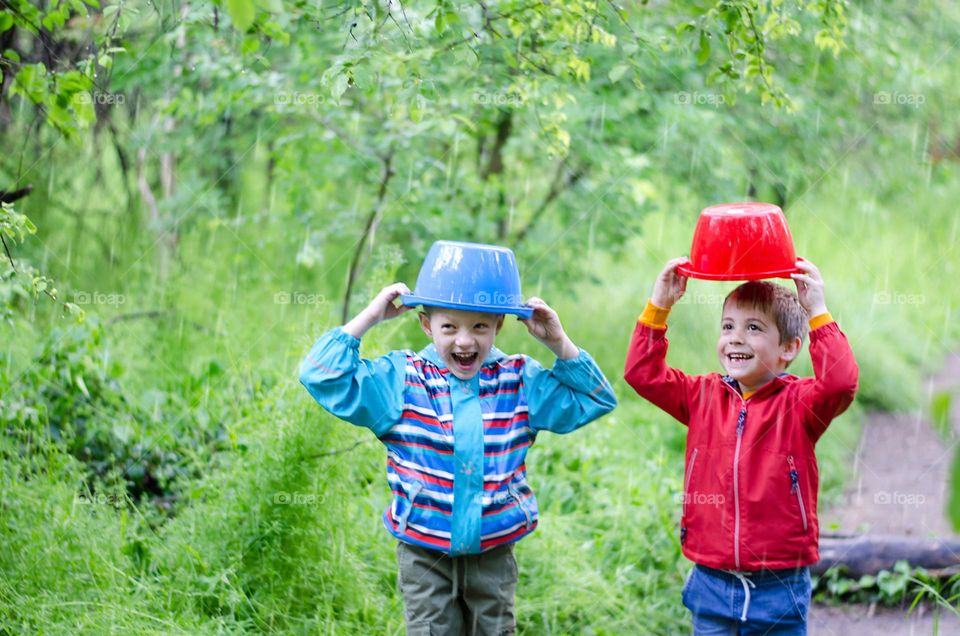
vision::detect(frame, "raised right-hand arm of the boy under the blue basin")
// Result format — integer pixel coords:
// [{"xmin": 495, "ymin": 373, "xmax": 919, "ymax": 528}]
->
[{"xmin": 521, "ymin": 298, "xmax": 617, "ymax": 433}]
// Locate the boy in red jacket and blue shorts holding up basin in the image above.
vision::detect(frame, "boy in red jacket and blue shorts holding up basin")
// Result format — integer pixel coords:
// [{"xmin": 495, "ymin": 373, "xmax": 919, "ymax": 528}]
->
[{"xmin": 624, "ymin": 258, "xmax": 858, "ymax": 634}]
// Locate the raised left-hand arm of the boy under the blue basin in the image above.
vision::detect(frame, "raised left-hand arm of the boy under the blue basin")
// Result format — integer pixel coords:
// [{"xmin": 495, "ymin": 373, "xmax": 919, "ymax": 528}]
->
[{"xmin": 300, "ymin": 283, "xmax": 409, "ymax": 437}]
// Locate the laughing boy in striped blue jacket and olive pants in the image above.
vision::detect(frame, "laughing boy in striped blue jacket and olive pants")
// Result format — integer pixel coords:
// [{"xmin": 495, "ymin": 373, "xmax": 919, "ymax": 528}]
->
[{"xmin": 300, "ymin": 283, "xmax": 616, "ymax": 636}]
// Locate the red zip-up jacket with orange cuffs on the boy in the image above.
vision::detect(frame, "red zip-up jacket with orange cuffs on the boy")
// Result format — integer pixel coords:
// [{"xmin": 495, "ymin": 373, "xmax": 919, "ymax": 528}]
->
[{"xmin": 624, "ymin": 322, "xmax": 859, "ymax": 571}]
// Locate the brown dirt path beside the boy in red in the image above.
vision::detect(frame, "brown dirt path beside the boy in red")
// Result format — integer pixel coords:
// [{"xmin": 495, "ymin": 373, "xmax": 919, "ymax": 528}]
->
[{"xmin": 810, "ymin": 354, "xmax": 960, "ymax": 636}]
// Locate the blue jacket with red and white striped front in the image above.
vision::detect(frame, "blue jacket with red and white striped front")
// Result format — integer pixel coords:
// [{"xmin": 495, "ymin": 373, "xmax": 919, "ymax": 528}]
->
[{"xmin": 300, "ymin": 327, "xmax": 617, "ymax": 556}]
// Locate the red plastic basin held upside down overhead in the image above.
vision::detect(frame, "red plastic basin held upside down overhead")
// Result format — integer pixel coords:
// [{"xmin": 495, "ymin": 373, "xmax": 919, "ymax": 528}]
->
[{"xmin": 677, "ymin": 203, "xmax": 800, "ymax": 280}]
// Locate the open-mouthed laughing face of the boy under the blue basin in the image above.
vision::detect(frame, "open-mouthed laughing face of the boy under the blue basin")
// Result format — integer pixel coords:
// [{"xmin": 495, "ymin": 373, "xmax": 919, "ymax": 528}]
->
[{"xmin": 420, "ymin": 307, "xmax": 503, "ymax": 380}]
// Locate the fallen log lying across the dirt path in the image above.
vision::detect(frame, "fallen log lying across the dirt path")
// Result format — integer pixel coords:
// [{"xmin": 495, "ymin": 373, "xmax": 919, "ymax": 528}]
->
[{"xmin": 810, "ymin": 535, "xmax": 960, "ymax": 578}]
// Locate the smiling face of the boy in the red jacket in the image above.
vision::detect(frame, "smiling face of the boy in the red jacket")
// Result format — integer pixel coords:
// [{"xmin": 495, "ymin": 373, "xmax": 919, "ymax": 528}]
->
[{"xmin": 717, "ymin": 300, "xmax": 801, "ymax": 393}]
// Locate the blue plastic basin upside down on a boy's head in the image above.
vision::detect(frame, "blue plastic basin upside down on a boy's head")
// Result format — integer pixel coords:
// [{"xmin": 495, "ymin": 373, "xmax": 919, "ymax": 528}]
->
[{"xmin": 400, "ymin": 241, "xmax": 533, "ymax": 318}]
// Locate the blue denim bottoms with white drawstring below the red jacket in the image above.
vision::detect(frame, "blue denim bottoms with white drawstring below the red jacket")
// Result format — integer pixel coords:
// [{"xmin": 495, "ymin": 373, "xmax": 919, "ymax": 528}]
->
[{"xmin": 682, "ymin": 565, "xmax": 811, "ymax": 636}]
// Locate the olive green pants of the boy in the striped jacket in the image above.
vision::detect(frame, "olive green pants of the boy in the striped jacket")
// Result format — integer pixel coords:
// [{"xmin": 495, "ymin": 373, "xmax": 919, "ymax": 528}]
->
[{"xmin": 397, "ymin": 541, "xmax": 517, "ymax": 636}]
